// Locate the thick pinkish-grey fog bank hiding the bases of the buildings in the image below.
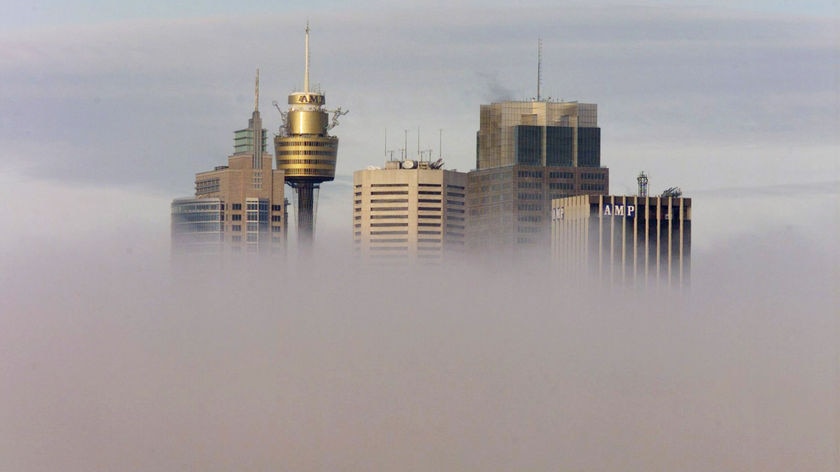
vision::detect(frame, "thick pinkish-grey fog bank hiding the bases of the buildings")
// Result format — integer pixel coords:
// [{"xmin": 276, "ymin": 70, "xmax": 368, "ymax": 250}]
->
[{"xmin": 0, "ymin": 227, "xmax": 838, "ymax": 472}]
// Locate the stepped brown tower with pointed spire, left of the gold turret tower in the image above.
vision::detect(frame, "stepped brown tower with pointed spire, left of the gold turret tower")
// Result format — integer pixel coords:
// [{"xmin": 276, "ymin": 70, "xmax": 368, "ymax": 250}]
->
[{"xmin": 172, "ymin": 71, "xmax": 286, "ymax": 254}]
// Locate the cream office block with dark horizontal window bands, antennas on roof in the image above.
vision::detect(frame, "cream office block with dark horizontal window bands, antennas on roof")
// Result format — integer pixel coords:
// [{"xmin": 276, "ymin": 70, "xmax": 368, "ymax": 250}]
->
[{"xmin": 353, "ymin": 160, "xmax": 467, "ymax": 262}]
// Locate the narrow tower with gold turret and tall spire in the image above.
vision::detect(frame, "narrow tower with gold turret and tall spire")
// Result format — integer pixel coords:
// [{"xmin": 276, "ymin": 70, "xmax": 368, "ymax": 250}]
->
[{"xmin": 274, "ymin": 23, "xmax": 343, "ymax": 247}]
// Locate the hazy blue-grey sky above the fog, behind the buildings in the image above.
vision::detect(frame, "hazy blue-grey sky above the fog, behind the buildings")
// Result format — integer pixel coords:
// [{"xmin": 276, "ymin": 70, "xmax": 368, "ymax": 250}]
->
[{"xmin": 0, "ymin": 1, "xmax": 840, "ymax": 241}]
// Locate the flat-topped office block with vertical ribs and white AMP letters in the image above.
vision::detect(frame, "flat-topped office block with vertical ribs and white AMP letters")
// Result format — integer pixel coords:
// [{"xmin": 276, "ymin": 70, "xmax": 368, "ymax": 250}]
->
[{"xmin": 551, "ymin": 193, "xmax": 691, "ymax": 287}]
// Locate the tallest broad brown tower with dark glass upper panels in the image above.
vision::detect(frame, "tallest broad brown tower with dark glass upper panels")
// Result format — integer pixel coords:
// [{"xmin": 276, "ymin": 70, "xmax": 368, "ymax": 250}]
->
[{"xmin": 467, "ymin": 100, "xmax": 609, "ymax": 254}]
